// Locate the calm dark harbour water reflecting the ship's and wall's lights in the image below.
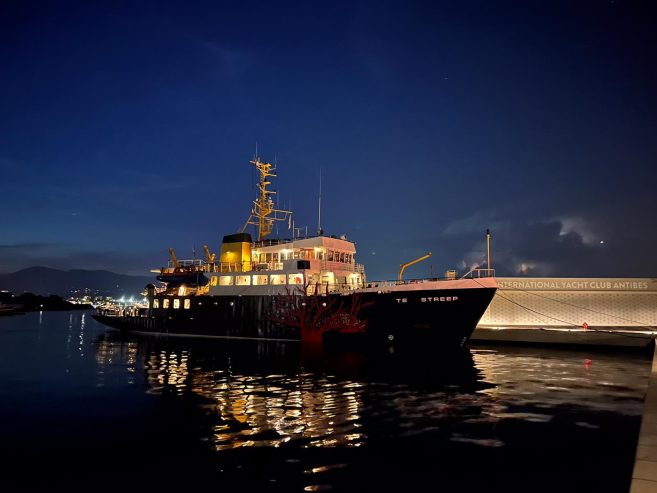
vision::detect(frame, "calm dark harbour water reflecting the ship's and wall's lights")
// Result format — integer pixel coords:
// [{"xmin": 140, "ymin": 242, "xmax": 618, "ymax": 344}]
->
[{"xmin": 0, "ymin": 312, "xmax": 650, "ymax": 493}]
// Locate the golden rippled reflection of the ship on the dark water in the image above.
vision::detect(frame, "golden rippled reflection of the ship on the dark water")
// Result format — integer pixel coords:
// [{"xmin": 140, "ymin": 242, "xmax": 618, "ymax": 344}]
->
[{"xmin": 97, "ymin": 332, "xmax": 487, "ymax": 451}]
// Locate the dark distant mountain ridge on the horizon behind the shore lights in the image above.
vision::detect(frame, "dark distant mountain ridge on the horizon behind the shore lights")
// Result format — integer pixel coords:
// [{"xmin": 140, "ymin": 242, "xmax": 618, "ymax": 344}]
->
[{"xmin": 0, "ymin": 267, "xmax": 155, "ymax": 297}]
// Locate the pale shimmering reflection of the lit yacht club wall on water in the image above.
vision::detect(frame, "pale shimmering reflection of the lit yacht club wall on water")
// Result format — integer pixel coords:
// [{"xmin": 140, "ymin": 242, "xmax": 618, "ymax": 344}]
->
[{"xmin": 473, "ymin": 348, "xmax": 649, "ymax": 420}]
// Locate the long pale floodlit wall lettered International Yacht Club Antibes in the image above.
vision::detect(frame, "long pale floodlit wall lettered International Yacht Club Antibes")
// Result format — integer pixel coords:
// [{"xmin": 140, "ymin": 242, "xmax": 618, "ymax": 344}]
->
[{"xmin": 471, "ymin": 277, "xmax": 657, "ymax": 347}]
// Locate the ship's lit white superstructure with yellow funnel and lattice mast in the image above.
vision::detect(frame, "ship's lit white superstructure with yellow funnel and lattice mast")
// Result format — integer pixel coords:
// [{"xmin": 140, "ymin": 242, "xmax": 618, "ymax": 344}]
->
[{"xmin": 155, "ymin": 158, "xmax": 365, "ymax": 296}]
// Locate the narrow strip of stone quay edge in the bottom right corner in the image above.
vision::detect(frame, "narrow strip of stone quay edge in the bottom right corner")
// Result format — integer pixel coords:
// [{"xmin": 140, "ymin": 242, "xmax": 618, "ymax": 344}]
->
[{"xmin": 630, "ymin": 348, "xmax": 657, "ymax": 493}]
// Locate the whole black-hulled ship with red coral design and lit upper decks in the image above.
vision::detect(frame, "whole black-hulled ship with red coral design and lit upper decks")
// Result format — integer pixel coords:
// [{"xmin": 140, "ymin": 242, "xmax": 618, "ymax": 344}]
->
[{"xmin": 94, "ymin": 157, "xmax": 497, "ymax": 348}]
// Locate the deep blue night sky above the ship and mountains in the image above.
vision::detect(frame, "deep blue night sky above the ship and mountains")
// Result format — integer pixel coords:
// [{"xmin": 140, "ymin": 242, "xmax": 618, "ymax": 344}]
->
[{"xmin": 0, "ymin": 0, "xmax": 657, "ymax": 279}]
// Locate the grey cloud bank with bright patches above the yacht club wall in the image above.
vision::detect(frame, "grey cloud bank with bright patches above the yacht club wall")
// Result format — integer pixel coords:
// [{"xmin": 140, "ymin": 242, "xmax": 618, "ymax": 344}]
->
[{"xmin": 438, "ymin": 201, "xmax": 657, "ymax": 277}]
